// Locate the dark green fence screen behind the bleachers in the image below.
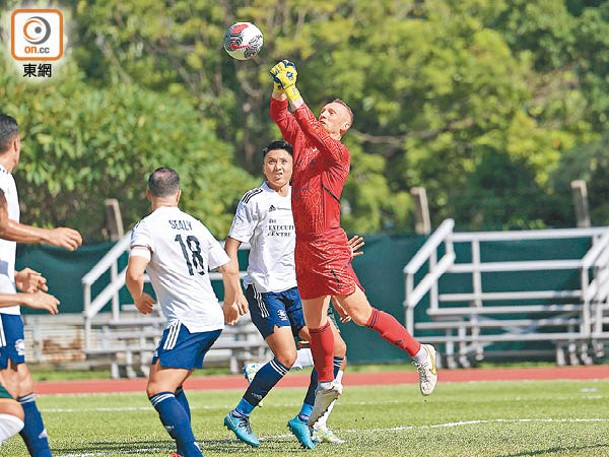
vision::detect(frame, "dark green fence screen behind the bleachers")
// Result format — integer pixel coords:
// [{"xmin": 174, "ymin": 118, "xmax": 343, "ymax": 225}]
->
[{"xmin": 17, "ymin": 235, "xmax": 589, "ymax": 363}]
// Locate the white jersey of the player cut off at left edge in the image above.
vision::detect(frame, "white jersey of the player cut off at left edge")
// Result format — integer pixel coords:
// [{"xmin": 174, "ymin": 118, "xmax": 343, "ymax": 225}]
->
[{"xmin": 0, "ymin": 165, "xmax": 21, "ymax": 315}]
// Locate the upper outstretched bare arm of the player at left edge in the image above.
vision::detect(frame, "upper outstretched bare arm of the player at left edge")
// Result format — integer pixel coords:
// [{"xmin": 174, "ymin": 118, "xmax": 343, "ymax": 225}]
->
[{"xmin": 2, "ymin": 219, "xmax": 82, "ymax": 251}]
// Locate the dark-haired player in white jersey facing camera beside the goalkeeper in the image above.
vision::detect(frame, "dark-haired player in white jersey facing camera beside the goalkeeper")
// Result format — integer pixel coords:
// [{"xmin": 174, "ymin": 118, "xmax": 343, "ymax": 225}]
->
[{"xmin": 224, "ymin": 141, "xmax": 356, "ymax": 449}]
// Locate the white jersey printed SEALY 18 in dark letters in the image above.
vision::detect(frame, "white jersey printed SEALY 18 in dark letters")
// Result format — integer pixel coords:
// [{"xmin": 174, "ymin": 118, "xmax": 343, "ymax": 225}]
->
[{"xmin": 131, "ymin": 207, "xmax": 230, "ymax": 332}]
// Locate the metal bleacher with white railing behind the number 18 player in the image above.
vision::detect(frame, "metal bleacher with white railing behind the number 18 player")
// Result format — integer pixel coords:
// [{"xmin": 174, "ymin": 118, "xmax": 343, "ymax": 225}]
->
[{"xmin": 82, "ymin": 234, "xmax": 266, "ymax": 378}]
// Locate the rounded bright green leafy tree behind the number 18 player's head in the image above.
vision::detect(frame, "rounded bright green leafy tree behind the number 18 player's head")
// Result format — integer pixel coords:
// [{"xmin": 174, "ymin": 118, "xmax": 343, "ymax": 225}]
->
[{"xmin": 0, "ymin": 57, "xmax": 256, "ymax": 241}]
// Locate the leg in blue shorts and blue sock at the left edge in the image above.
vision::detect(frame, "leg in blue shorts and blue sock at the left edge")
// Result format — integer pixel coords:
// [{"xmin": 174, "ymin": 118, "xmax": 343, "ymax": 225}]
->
[{"xmin": 0, "ymin": 314, "xmax": 52, "ymax": 457}]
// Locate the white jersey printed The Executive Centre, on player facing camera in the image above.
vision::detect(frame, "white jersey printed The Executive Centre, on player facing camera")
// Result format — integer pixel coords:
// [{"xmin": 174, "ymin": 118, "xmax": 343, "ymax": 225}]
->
[{"xmin": 228, "ymin": 182, "xmax": 296, "ymax": 293}]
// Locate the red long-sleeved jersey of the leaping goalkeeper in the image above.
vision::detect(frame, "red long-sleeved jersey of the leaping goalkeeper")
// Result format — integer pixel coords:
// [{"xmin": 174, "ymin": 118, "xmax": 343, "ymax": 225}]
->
[{"xmin": 271, "ymin": 97, "xmax": 351, "ymax": 235}]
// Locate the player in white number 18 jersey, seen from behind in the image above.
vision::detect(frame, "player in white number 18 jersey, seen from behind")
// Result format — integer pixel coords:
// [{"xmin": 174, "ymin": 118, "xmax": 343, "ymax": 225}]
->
[{"xmin": 126, "ymin": 168, "xmax": 247, "ymax": 457}]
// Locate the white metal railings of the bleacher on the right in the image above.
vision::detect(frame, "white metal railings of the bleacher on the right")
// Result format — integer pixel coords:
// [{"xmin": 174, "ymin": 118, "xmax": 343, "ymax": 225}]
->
[{"xmin": 404, "ymin": 219, "xmax": 609, "ymax": 361}]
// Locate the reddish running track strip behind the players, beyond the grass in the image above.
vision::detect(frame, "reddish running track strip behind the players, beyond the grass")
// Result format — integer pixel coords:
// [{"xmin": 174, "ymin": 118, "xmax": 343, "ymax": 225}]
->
[{"xmin": 36, "ymin": 365, "xmax": 609, "ymax": 395}]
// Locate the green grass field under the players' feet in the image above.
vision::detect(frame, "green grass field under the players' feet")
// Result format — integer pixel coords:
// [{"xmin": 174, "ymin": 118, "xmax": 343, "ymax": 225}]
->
[{"xmin": 0, "ymin": 380, "xmax": 609, "ymax": 457}]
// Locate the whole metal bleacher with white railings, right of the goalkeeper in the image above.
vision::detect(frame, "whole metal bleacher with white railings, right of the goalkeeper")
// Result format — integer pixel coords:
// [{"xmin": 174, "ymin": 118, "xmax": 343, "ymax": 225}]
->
[{"xmin": 404, "ymin": 219, "xmax": 609, "ymax": 368}]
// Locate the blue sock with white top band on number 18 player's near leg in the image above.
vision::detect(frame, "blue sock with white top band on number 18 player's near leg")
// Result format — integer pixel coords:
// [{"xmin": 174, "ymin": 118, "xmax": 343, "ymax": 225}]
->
[{"xmin": 149, "ymin": 392, "xmax": 203, "ymax": 457}]
